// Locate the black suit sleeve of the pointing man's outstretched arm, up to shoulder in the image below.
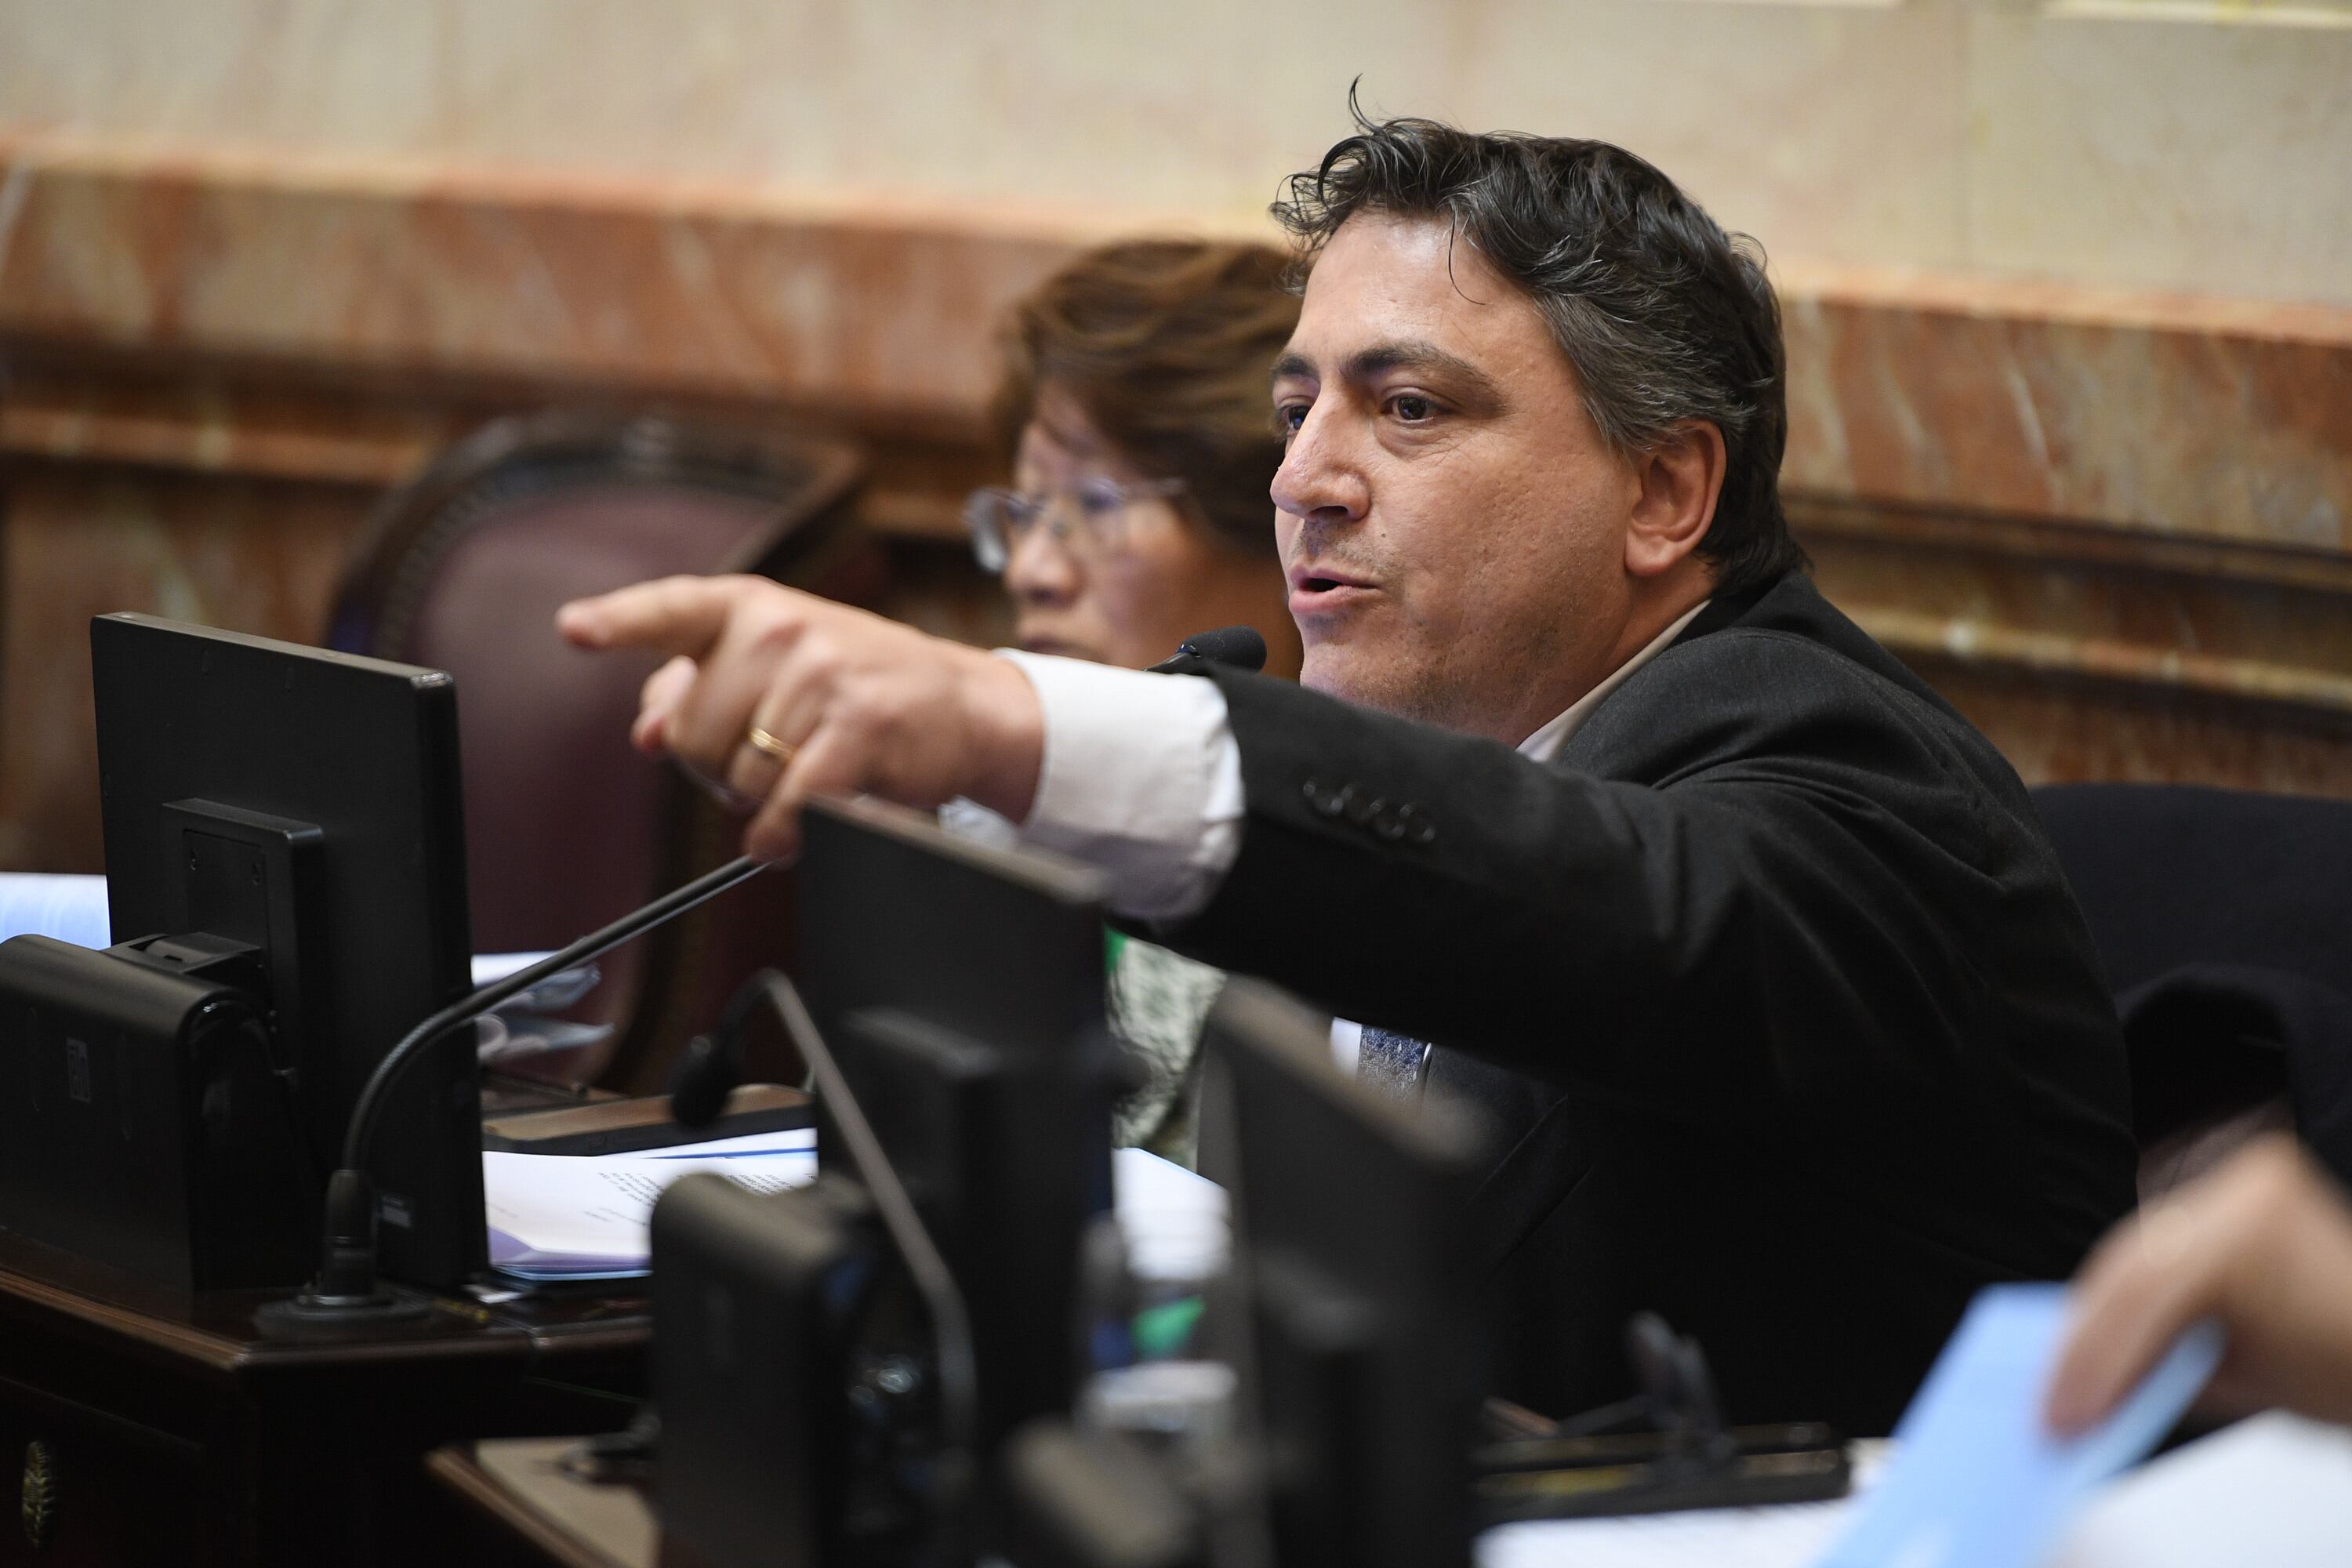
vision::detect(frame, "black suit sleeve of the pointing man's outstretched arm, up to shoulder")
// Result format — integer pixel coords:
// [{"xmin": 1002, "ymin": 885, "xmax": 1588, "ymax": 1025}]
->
[{"xmin": 1162, "ymin": 635, "xmax": 2009, "ymax": 1121}]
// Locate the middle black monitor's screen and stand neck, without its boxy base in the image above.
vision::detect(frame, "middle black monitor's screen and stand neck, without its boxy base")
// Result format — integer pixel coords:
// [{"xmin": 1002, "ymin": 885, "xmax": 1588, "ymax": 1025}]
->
[{"xmin": 800, "ymin": 801, "xmax": 1110, "ymax": 1446}]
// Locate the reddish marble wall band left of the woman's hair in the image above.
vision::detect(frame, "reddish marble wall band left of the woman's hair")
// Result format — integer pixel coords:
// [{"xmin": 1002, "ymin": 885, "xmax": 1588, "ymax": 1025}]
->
[{"xmin": 0, "ymin": 146, "xmax": 1073, "ymax": 430}]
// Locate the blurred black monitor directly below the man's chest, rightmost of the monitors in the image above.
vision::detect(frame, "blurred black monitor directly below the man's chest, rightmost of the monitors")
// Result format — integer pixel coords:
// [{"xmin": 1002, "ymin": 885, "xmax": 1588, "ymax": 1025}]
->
[{"xmin": 1202, "ymin": 980, "xmax": 1486, "ymax": 1568}]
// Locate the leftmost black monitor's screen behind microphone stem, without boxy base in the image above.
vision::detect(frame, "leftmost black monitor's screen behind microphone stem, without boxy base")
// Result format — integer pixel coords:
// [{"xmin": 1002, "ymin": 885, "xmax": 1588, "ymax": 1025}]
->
[{"xmin": 89, "ymin": 614, "xmax": 485, "ymax": 1288}]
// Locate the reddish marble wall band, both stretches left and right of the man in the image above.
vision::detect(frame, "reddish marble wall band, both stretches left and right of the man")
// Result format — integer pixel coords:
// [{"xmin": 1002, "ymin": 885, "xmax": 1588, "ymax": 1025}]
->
[{"xmin": 0, "ymin": 143, "xmax": 2352, "ymax": 550}]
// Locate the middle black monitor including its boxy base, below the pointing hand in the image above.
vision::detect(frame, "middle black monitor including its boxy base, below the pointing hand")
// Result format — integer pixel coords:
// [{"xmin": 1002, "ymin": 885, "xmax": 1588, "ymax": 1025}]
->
[{"xmin": 654, "ymin": 801, "xmax": 1110, "ymax": 1566}]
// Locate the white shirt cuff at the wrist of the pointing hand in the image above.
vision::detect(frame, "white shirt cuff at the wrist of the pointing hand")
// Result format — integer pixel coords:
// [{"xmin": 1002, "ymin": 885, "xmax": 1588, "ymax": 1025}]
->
[{"xmin": 997, "ymin": 649, "xmax": 1242, "ymax": 919}]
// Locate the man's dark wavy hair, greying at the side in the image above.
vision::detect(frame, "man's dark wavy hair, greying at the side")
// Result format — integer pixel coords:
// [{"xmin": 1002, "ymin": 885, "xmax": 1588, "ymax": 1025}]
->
[{"xmin": 1272, "ymin": 92, "xmax": 1804, "ymax": 595}]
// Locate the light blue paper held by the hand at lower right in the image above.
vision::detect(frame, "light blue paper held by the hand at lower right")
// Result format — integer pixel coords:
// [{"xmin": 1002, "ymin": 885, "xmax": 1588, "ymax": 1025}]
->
[{"xmin": 1816, "ymin": 1286, "xmax": 2220, "ymax": 1568}]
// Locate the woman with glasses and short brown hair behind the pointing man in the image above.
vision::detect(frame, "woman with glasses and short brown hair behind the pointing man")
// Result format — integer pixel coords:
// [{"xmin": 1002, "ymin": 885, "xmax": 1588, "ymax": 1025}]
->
[{"xmin": 964, "ymin": 240, "xmax": 1298, "ymax": 1163}]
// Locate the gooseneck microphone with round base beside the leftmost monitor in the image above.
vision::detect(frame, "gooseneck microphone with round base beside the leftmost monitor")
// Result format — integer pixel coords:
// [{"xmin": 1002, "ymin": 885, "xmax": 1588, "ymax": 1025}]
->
[{"xmin": 254, "ymin": 855, "xmax": 769, "ymax": 1333}]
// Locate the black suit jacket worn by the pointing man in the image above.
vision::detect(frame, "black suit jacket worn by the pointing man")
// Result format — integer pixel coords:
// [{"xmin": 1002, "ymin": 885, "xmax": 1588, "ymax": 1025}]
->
[{"xmin": 1162, "ymin": 574, "xmax": 2133, "ymax": 1432}]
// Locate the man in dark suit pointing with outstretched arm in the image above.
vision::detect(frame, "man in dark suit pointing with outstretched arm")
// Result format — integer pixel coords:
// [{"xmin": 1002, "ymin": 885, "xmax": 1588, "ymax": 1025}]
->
[{"xmin": 562, "ymin": 120, "xmax": 2133, "ymax": 1432}]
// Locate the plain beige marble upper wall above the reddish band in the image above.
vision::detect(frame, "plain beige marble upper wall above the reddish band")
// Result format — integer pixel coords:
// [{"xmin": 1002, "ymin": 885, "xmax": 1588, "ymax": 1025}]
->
[{"xmin": 0, "ymin": 0, "xmax": 2352, "ymax": 303}]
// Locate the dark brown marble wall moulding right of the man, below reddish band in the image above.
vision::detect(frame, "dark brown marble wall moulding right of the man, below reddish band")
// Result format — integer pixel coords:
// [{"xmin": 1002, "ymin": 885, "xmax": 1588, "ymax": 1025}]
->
[{"xmin": 1792, "ymin": 501, "xmax": 2352, "ymax": 797}]
